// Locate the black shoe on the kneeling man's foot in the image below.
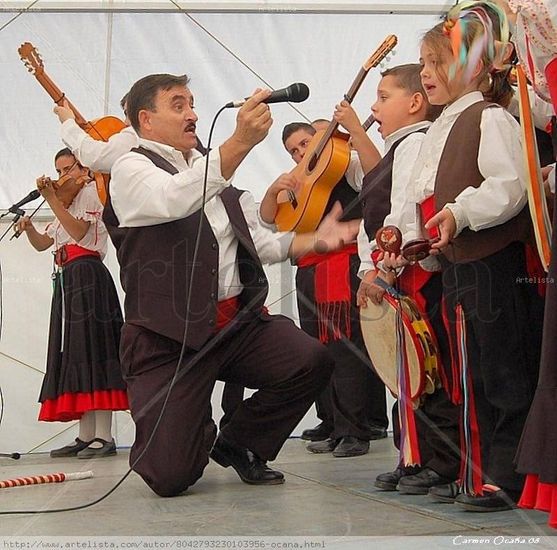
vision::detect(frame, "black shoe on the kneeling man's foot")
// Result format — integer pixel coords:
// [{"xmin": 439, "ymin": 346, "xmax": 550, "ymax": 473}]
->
[{"xmin": 209, "ymin": 436, "xmax": 284, "ymax": 485}]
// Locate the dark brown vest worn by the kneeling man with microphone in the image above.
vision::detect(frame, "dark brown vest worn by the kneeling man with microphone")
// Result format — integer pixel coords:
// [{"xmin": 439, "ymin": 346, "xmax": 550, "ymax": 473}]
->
[{"xmin": 103, "ymin": 147, "xmax": 268, "ymax": 350}]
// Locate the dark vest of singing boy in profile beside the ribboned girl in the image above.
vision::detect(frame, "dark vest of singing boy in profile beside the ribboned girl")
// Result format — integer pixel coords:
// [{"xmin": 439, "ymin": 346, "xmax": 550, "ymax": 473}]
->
[{"xmin": 360, "ymin": 132, "xmax": 427, "ymax": 239}]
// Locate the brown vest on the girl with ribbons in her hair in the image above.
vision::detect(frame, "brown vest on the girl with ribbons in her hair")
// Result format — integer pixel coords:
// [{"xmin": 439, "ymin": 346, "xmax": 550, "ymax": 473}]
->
[{"xmin": 434, "ymin": 101, "xmax": 532, "ymax": 263}]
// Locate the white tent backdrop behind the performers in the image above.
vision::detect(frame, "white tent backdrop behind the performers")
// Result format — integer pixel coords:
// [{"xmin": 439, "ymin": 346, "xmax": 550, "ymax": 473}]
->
[{"xmin": 0, "ymin": 0, "xmax": 447, "ymax": 451}]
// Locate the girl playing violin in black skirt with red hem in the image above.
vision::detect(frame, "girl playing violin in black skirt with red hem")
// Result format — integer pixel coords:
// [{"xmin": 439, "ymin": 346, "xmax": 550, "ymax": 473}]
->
[{"xmin": 16, "ymin": 149, "xmax": 128, "ymax": 458}]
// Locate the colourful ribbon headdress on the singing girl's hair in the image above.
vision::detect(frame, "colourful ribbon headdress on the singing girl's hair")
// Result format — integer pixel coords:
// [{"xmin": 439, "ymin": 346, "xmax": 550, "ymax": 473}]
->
[{"xmin": 443, "ymin": 0, "xmax": 510, "ymax": 82}]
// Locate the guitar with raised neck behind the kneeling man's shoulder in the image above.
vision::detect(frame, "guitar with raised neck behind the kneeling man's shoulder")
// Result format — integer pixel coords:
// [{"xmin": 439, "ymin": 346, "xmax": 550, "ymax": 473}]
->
[{"xmin": 18, "ymin": 42, "xmax": 126, "ymax": 204}]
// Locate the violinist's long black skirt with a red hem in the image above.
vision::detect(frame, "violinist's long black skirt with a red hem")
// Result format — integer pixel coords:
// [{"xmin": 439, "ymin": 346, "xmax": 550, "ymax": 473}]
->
[{"xmin": 39, "ymin": 255, "xmax": 129, "ymax": 422}]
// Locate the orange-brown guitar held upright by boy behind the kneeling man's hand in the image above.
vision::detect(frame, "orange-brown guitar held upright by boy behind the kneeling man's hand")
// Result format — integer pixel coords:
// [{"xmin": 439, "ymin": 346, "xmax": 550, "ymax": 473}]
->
[{"xmin": 275, "ymin": 35, "xmax": 397, "ymax": 233}]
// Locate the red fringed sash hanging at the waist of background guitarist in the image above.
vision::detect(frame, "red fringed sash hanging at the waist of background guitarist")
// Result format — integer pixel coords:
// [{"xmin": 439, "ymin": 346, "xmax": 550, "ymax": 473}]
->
[{"xmin": 296, "ymin": 244, "xmax": 358, "ymax": 343}]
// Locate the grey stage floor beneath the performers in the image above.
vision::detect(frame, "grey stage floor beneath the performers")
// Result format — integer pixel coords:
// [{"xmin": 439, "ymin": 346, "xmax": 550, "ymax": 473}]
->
[{"xmin": 0, "ymin": 438, "xmax": 557, "ymax": 549}]
